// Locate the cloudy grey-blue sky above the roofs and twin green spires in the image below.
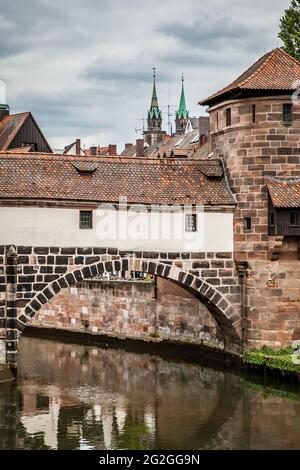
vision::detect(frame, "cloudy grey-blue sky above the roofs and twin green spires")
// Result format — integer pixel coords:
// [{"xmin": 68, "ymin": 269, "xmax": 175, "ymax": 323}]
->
[{"xmin": 0, "ymin": 0, "xmax": 290, "ymax": 151}]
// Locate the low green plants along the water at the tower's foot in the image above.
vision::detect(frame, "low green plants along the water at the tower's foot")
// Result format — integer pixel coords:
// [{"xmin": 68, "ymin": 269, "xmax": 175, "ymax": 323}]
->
[{"xmin": 243, "ymin": 346, "xmax": 300, "ymax": 373}]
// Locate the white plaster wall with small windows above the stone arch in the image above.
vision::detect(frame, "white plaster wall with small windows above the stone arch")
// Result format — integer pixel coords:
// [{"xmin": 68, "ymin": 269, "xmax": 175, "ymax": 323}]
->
[{"xmin": 0, "ymin": 207, "xmax": 233, "ymax": 251}]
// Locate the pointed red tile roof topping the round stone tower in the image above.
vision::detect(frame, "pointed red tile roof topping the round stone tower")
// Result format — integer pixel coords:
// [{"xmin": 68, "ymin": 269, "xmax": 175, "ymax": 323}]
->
[{"xmin": 199, "ymin": 48, "xmax": 300, "ymax": 105}]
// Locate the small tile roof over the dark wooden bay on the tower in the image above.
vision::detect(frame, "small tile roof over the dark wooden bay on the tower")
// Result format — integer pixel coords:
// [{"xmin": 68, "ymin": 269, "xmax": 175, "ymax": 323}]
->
[{"xmin": 266, "ymin": 176, "xmax": 300, "ymax": 208}]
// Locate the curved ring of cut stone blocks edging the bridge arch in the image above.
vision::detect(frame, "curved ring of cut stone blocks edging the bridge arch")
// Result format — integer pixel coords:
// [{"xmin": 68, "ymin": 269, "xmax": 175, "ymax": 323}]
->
[{"xmin": 17, "ymin": 257, "xmax": 241, "ymax": 348}]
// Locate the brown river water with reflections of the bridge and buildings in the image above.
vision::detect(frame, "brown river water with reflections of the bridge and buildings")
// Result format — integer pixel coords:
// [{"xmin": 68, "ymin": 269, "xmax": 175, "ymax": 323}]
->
[{"xmin": 0, "ymin": 337, "xmax": 300, "ymax": 449}]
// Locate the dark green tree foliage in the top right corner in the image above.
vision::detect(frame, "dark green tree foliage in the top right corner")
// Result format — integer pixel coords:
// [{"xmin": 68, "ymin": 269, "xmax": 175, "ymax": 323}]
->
[{"xmin": 278, "ymin": 0, "xmax": 300, "ymax": 60}]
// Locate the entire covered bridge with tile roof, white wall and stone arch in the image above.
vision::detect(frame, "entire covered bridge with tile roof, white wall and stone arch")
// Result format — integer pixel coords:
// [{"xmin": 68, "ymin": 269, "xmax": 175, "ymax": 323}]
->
[{"xmin": 0, "ymin": 152, "xmax": 241, "ymax": 370}]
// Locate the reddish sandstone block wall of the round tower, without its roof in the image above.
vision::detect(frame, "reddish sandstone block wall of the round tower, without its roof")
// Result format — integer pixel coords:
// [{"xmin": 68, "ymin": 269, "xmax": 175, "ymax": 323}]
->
[{"xmin": 210, "ymin": 96, "xmax": 300, "ymax": 347}]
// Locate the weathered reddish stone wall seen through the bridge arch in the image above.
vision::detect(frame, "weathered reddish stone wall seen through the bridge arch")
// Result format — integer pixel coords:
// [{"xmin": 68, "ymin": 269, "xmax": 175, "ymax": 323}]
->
[{"xmin": 31, "ymin": 279, "xmax": 224, "ymax": 349}]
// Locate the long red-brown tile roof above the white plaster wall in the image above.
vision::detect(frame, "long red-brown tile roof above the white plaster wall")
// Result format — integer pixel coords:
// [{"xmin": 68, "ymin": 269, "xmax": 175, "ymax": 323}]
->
[{"xmin": 0, "ymin": 152, "xmax": 234, "ymax": 205}]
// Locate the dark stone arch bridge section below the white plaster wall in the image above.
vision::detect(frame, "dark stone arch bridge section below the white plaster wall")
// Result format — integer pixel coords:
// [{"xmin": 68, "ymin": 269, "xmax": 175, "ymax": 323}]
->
[{"xmin": 0, "ymin": 246, "xmax": 242, "ymax": 367}]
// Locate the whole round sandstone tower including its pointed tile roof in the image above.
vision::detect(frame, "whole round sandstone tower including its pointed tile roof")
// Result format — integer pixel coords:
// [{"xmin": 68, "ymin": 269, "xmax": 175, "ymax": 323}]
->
[{"xmin": 201, "ymin": 49, "xmax": 300, "ymax": 347}]
